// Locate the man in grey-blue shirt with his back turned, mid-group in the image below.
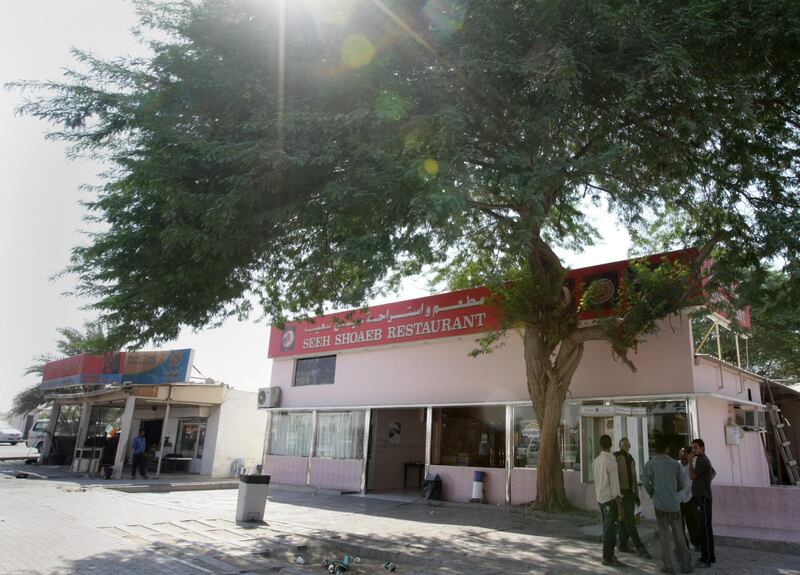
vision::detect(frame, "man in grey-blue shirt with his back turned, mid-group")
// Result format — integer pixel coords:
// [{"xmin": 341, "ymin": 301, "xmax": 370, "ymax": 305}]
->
[{"xmin": 643, "ymin": 437, "xmax": 692, "ymax": 573}]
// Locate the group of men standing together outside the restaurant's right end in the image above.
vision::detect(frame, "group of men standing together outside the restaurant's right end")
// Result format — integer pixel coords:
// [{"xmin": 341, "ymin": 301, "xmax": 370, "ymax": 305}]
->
[{"xmin": 593, "ymin": 435, "xmax": 716, "ymax": 573}]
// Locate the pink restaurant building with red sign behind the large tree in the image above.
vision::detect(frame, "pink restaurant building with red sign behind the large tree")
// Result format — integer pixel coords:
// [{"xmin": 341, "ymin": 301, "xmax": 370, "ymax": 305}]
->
[{"xmin": 264, "ymin": 264, "xmax": 800, "ymax": 540}]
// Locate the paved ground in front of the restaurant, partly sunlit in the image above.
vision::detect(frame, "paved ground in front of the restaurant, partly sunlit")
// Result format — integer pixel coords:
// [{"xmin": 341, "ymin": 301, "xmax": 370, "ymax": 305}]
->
[{"xmin": 0, "ymin": 470, "xmax": 800, "ymax": 575}]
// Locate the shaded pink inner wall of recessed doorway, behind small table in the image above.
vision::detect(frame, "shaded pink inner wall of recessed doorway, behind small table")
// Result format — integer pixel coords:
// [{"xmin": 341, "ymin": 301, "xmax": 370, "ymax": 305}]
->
[{"xmin": 368, "ymin": 408, "xmax": 425, "ymax": 490}]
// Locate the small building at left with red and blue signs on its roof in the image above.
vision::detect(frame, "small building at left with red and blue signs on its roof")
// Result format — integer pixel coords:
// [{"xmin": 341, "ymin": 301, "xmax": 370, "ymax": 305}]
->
[{"xmin": 41, "ymin": 350, "xmax": 266, "ymax": 478}]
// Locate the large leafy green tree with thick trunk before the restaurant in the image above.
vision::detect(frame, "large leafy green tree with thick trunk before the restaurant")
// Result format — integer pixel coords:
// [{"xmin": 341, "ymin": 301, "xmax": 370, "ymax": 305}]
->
[{"xmin": 15, "ymin": 0, "xmax": 800, "ymax": 508}]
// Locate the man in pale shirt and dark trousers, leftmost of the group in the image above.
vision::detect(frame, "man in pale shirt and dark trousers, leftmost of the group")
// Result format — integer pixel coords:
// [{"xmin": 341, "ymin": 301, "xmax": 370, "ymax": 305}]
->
[{"xmin": 592, "ymin": 435, "xmax": 624, "ymax": 567}]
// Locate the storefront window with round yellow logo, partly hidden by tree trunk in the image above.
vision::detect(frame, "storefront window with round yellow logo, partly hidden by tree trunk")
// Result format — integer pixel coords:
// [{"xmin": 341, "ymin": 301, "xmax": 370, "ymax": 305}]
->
[{"xmin": 514, "ymin": 404, "xmax": 581, "ymax": 469}]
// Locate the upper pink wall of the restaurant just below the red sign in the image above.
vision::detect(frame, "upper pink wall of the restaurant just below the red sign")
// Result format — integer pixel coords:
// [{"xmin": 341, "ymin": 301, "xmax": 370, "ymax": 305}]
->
[{"xmin": 270, "ymin": 318, "xmax": 693, "ymax": 407}]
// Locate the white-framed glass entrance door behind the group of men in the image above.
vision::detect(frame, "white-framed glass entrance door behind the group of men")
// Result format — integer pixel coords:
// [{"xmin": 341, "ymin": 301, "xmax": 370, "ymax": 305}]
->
[{"xmin": 581, "ymin": 405, "xmax": 650, "ymax": 483}]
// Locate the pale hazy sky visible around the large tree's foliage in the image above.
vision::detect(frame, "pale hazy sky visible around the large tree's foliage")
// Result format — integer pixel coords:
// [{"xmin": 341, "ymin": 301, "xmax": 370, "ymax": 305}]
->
[{"xmin": 0, "ymin": 0, "xmax": 630, "ymax": 412}]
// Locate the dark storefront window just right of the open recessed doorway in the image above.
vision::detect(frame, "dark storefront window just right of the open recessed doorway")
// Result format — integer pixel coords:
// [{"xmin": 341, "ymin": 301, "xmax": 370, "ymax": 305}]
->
[{"xmin": 432, "ymin": 405, "xmax": 506, "ymax": 467}]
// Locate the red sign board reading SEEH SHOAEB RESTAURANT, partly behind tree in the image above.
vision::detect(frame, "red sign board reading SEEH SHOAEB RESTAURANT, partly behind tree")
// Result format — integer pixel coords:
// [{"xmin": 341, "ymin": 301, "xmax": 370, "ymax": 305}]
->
[{"xmin": 269, "ymin": 250, "xmax": 736, "ymax": 357}]
